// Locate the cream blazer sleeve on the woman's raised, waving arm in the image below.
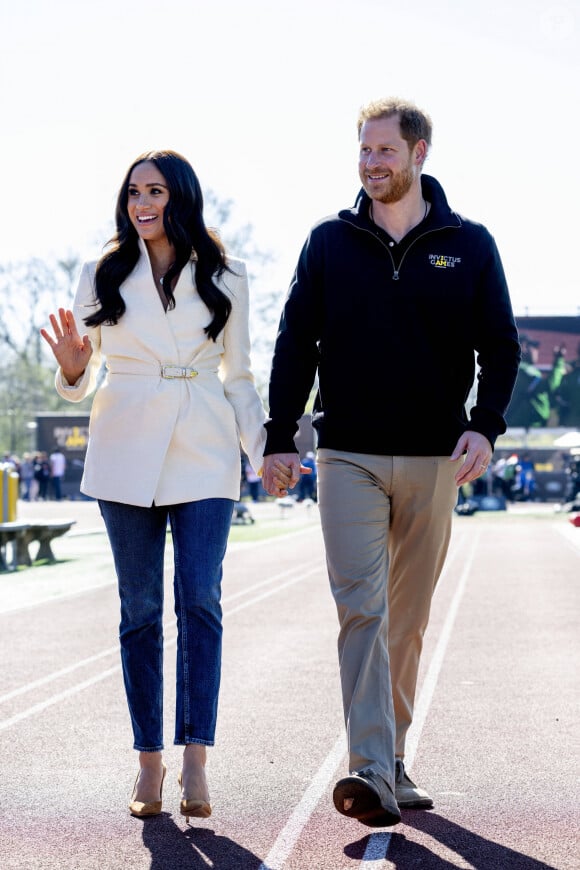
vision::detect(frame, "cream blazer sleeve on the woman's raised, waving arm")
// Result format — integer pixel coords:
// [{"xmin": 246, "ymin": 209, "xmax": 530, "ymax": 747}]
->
[{"xmin": 55, "ymin": 263, "xmax": 103, "ymax": 402}]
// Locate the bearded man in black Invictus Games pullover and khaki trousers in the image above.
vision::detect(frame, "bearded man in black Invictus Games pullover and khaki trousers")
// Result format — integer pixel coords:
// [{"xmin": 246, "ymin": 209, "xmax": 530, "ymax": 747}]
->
[{"xmin": 263, "ymin": 99, "xmax": 519, "ymax": 827}]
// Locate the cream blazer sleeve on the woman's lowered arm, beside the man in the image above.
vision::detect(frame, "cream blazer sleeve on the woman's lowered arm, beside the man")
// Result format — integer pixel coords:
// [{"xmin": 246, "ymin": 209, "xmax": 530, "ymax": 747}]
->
[{"xmin": 219, "ymin": 260, "xmax": 266, "ymax": 472}]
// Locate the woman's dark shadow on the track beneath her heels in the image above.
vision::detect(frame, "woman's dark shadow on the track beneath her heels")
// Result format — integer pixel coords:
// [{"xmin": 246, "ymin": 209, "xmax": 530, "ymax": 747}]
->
[{"xmin": 143, "ymin": 813, "xmax": 262, "ymax": 870}]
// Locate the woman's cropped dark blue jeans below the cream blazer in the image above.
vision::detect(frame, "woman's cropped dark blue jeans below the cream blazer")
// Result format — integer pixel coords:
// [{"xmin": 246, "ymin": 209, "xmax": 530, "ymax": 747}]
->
[{"xmin": 99, "ymin": 498, "xmax": 234, "ymax": 752}]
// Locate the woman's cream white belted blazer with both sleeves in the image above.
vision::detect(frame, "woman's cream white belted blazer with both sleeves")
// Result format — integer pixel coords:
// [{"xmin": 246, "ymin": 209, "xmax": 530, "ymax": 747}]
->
[{"xmin": 56, "ymin": 242, "xmax": 266, "ymax": 507}]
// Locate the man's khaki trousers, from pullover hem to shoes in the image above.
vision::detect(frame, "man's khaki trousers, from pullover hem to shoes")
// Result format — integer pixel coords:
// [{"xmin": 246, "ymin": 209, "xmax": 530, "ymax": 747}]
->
[{"xmin": 318, "ymin": 449, "xmax": 463, "ymax": 786}]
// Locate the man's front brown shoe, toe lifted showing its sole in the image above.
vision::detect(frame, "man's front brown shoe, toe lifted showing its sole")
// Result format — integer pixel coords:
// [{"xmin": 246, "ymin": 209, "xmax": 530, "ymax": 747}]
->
[{"xmin": 332, "ymin": 770, "xmax": 401, "ymax": 828}]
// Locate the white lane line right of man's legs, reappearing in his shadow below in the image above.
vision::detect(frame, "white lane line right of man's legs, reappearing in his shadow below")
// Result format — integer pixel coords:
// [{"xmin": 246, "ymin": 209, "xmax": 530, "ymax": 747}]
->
[{"xmin": 362, "ymin": 532, "xmax": 481, "ymax": 870}]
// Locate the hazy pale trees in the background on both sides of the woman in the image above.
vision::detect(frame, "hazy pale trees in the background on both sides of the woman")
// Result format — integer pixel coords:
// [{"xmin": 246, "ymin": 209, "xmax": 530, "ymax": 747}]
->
[{"xmin": 0, "ymin": 190, "xmax": 283, "ymax": 456}]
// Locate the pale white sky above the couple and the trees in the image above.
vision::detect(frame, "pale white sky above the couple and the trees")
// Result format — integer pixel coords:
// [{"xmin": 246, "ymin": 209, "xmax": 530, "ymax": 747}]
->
[{"xmin": 0, "ymin": 0, "xmax": 580, "ymax": 314}]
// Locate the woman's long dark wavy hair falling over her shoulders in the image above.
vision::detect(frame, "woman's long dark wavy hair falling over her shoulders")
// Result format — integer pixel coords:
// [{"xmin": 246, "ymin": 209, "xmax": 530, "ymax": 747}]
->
[{"xmin": 85, "ymin": 151, "xmax": 232, "ymax": 341}]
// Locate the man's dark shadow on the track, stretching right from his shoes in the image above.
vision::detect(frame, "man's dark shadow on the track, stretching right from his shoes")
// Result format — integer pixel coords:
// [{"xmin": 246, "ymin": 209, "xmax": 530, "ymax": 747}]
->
[{"xmin": 344, "ymin": 810, "xmax": 557, "ymax": 870}]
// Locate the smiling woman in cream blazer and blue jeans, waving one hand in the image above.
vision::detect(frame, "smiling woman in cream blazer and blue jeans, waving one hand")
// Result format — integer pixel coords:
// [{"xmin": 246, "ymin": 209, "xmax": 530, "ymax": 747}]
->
[{"xmin": 41, "ymin": 151, "xmax": 288, "ymax": 818}]
